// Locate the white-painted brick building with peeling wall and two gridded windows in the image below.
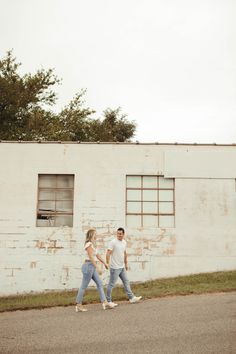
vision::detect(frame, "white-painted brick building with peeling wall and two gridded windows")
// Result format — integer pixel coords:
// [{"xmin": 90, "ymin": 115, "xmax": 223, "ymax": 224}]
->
[{"xmin": 0, "ymin": 142, "xmax": 236, "ymax": 295}]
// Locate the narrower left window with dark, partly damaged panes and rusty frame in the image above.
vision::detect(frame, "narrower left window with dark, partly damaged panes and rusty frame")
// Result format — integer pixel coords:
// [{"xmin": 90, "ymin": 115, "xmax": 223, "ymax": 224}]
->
[{"xmin": 36, "ymin": 174, "xmax": 74, "ymax": 227}]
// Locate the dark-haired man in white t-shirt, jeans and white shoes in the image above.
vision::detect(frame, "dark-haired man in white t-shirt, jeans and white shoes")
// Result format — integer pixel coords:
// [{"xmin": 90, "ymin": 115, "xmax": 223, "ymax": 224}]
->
[{"xmin": 106, "ymin": 227, "xmax": 142, "ymax": 307}]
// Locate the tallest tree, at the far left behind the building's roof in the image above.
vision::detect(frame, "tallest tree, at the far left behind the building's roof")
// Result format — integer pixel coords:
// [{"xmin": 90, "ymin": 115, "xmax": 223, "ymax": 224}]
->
[{"xmin": 0, "ymin": 51, "xmax": 59, "ymax": 140}]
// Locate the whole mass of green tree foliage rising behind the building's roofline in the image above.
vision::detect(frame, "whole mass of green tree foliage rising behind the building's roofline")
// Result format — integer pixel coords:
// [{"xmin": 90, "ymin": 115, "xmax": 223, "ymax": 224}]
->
[{"xmin": 0, "ymin": 51, "xmax": 136, "ymax": 142}]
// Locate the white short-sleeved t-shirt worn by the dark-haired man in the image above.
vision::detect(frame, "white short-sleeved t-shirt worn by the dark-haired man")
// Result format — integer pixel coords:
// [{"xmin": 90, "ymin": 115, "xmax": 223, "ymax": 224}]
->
[{"xmin": 108, "ymin": 238, "xmax": 126, "ymax": 269}]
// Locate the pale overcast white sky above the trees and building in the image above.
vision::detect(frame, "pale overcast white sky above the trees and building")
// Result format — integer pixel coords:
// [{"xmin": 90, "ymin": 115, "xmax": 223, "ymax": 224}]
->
[{"xmin": 0, "ymin": 0, "xmax": 236, "ymax": 144}]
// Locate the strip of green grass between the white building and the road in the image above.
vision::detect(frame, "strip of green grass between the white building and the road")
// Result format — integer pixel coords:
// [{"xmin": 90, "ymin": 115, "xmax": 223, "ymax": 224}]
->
[{"xmin": 0, "ymin": 270, "xmax": 236, "ymax": 312}]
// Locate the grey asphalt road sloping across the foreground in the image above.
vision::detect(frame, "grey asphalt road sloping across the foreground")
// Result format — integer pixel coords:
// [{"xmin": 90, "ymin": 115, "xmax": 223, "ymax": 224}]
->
[{"xmin": 0, "ymin": 292, "xmax": 236, "ymax": 354}]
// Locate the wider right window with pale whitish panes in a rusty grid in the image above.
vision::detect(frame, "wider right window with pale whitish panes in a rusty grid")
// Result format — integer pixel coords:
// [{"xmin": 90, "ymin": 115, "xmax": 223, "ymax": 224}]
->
[{"xmin": 126, "ymin": 176, "xmax": 175, "ymax": 228}]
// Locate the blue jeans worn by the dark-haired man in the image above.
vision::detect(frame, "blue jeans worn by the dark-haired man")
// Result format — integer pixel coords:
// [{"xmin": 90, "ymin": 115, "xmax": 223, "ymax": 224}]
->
[{"xmin": 107, "ymin": 268, "xmax": 134, "ymax": 302}]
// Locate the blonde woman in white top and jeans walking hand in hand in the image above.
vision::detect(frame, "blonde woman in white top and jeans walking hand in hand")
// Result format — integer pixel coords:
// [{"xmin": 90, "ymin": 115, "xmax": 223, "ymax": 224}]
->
[{"xmin": 75, "ymin": 229, "xmax": 114, "ymax": 312}]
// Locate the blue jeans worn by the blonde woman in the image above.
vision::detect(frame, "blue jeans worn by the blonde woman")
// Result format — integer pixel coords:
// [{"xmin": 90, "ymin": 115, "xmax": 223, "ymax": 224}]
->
[{"xmin": 76, "ymin": 262, "xmax": 106, "ymax": 304}]
